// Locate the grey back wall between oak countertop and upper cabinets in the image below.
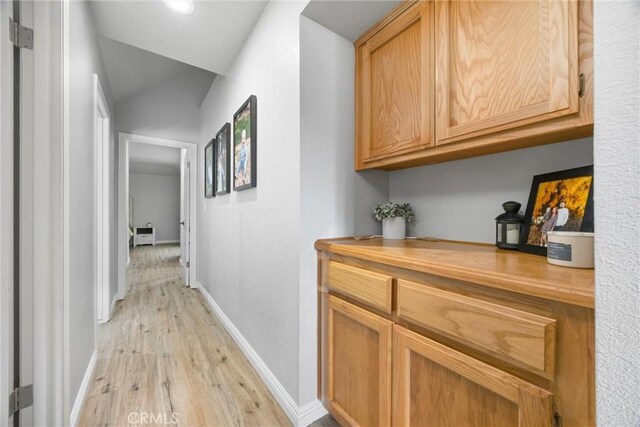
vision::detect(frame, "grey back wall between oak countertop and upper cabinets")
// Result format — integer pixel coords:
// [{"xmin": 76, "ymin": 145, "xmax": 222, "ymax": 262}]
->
[{"xmin": 389, "ymin": 138, "xmax": 593, "ymax": 243}]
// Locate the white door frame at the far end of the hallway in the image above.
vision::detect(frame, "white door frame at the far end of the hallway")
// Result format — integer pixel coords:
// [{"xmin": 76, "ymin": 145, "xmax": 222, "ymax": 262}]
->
[{"xmin": 118, "ymin": 132, "xmax": 198, "ymax": 299}]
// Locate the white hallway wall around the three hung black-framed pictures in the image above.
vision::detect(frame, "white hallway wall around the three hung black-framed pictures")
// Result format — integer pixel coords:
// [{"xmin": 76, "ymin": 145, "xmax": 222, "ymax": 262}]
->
[{"xmin": 197, "ymin": 1, "xmax": 308, "ymax": 408}]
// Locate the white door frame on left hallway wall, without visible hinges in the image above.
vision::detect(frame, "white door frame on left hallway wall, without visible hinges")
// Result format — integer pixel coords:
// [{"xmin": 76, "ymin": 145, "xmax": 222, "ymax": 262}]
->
[{"xmin": 93, "ymin": 74, "xmax": 112, "ymax": 323}]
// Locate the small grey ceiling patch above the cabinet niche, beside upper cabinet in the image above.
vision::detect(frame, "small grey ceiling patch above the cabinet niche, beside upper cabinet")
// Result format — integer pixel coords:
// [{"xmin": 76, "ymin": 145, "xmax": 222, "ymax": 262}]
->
[{"xmin": 302, "ymin": 0, "xmax": 400, "ymax": 41}]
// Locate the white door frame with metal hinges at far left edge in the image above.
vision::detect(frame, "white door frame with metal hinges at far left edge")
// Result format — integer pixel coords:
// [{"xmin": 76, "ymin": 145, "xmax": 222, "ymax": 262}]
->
[{"xmin": 0, "ymin": 0, "xmax": 69, "ymax": 425}]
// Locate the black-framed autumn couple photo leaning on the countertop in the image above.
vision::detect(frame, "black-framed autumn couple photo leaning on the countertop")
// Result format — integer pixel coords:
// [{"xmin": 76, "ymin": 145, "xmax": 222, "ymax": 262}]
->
[{"xmin": 518, "ymin": 165, "xmax": 593, "ymax": 256}]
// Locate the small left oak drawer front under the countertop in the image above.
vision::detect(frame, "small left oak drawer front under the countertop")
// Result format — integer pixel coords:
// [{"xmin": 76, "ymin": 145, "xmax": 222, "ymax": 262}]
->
[{"xmin": 327, "ymin": 261, "xmax": 393, "ymax": 313}]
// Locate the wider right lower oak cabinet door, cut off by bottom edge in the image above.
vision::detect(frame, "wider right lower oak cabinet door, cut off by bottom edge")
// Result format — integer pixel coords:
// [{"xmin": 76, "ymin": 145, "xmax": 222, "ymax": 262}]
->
[{"xmin": 393, "ymin": 325, "xmax": 553, "ymax": 427}]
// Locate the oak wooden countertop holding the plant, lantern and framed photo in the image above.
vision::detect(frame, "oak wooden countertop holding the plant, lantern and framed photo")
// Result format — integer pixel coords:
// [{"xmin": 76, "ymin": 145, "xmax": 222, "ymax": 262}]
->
[{"xmin": 315, "ymin": 238, "xmax": 594, "ymax": 308}]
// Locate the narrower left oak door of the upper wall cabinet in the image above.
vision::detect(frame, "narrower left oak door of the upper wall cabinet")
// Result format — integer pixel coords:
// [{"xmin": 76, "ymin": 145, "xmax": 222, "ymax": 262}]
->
[{"xmin": 356, "ymin": 2, "xmax": 434, "ymax": 169}]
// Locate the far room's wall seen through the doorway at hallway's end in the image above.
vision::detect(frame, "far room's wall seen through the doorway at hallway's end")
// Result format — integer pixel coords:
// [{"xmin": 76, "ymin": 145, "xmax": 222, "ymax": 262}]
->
[{"xmin": 129, "ymin": 173, "xmax": 180, "ymax": 242}]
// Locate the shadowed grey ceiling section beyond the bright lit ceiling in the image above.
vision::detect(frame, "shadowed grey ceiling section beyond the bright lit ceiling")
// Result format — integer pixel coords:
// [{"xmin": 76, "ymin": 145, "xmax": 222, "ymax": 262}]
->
[{"xmin": 98, "ymin": 37, "xmax": 216, "ymax": 103}]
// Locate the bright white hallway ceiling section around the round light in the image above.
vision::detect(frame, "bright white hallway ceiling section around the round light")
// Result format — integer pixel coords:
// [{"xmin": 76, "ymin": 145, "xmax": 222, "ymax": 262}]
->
[{"xmin": 91, "ymin": 0, "xmax": 267, "ymax": 74}]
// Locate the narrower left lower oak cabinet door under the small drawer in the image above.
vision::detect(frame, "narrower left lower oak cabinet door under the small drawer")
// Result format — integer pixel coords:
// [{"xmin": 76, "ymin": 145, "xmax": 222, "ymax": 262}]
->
[{"xmin": 327, "ymin": 296, "xmax": 393, "ymax": 426}]
